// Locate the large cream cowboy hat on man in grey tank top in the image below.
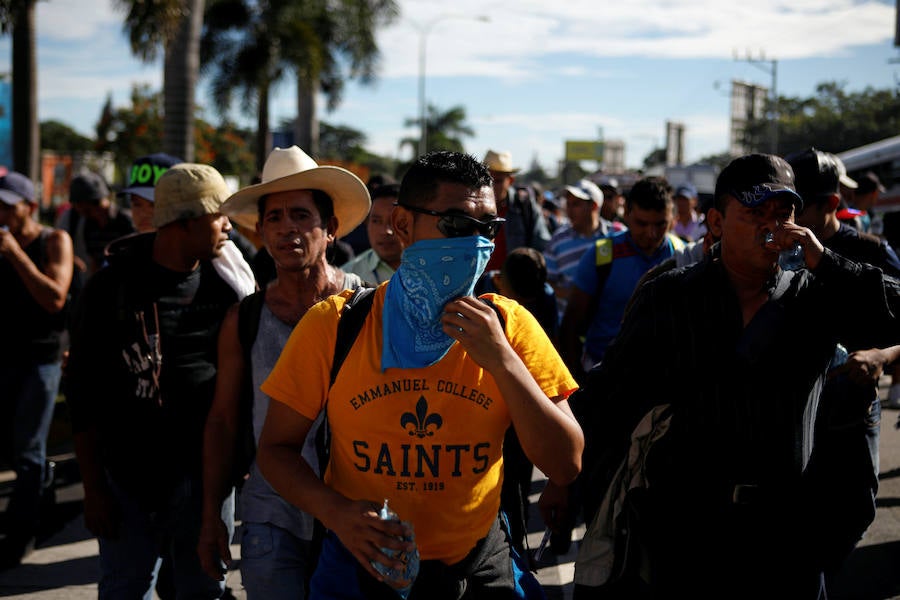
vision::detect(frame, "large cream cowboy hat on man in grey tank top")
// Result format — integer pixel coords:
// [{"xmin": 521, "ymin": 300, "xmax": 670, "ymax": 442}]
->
[{"xmin": 222, "ymin": 146, "xmax": 372, "ymax": 238}]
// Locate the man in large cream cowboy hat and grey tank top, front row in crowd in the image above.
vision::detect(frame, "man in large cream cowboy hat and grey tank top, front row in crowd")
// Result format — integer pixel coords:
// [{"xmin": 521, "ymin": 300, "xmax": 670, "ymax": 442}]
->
[{"xmin": 198, "ymin": 146, "xmax": 370, "ymax": 600}]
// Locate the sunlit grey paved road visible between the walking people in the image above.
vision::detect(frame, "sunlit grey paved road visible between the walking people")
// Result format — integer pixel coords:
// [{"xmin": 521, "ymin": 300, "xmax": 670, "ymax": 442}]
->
[{"xmin": 0, "ymin": 392, "xmax": 900, "ymax": 600}]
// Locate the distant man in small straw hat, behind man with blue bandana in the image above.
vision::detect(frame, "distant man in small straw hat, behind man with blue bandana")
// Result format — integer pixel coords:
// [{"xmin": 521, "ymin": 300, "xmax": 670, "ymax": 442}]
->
[{"xmin": 484, "ymin": 150, "xmax": 550, "ymax": 270}]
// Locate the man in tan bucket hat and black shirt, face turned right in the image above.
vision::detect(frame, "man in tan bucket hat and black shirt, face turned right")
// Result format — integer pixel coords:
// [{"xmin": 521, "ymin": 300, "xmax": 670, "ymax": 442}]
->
[{"xmin": 67, "ymin": 163, "xmax": 253, "ymax": 598}]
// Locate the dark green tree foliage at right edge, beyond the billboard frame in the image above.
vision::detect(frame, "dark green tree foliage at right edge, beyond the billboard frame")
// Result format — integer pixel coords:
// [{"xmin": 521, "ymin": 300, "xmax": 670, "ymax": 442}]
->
[{"xmin": 744, "ymin": 81, "xmax": 900, "ymax": 155}]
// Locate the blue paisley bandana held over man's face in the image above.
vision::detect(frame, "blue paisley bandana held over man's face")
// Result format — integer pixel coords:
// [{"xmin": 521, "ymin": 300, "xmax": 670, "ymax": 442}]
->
[{"xmin": 381, "ymin": 236, "xmax": 494, "ymax": 371}]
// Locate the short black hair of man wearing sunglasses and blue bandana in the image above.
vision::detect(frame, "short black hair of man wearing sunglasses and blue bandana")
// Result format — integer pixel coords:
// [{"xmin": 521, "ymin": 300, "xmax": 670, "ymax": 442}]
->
[{"xmin": 397, "ymin": 150, "xmax": 494, "ymax": 207}]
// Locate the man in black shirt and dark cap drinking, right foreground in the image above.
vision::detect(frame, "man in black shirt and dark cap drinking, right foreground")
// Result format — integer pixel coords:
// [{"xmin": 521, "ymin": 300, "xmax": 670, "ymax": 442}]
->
[{"xmin": 574, "ymin": 154, "xmax": 900, "ymax": 598}]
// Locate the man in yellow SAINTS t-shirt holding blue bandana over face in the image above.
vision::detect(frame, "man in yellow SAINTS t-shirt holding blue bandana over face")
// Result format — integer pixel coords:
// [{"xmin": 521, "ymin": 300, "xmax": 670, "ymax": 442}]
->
[{"xmin": 257, "ymin": 152, "xmax": 584, "ymax": 600}]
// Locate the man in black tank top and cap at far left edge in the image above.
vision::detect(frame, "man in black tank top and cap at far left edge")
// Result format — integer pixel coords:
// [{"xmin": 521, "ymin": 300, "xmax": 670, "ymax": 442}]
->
[{"xmin": 0, "ymin": 171, "xmax": 73, "ymax": 568}]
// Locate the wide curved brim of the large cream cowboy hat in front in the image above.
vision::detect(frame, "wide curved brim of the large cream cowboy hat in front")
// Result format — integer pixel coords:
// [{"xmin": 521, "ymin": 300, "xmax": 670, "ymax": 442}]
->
[{"xmin": 221, "ymin": 165, "xmax": 372, "ymax": 238}]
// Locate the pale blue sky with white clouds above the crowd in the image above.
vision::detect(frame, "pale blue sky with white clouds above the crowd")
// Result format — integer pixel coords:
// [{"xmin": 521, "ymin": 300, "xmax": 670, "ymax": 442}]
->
[{"xmin": 0, "ymin": 0, "xmax": 900, "ymax": 173}]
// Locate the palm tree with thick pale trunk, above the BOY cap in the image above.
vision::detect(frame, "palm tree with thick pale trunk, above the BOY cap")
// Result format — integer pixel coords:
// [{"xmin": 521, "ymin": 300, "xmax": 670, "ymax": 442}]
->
[{"xmin": 113, "ymin": 0, "xmax": 204, "ymax": 162}]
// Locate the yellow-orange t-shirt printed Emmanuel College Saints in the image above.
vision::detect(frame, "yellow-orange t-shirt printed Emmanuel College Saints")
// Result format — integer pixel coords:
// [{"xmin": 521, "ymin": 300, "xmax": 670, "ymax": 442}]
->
[{"xmin": 262, "ymin": 283, "xmax": 577, "ymax": 564}]
